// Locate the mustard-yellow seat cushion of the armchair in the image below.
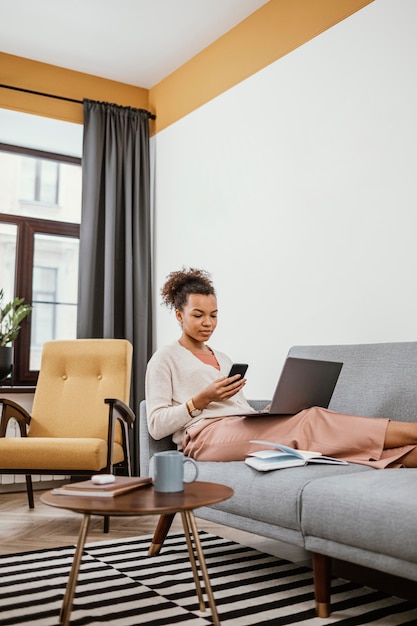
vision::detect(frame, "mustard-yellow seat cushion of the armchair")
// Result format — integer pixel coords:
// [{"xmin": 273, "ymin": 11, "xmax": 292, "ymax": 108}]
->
[{"xmin": 0, "ymin": 437, "xmax": 124, "ymax": 471}]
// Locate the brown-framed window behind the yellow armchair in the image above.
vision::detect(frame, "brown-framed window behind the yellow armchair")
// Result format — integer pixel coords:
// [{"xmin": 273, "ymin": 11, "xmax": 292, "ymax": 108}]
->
[{"xmin": 0, "ymin": 144, "xmax": 81, "ymax": 385}]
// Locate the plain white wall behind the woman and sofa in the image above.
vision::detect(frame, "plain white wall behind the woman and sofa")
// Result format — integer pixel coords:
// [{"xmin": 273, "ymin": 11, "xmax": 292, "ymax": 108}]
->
[{"xmin": 153, "ymin": 0, "xmax": 417, "ymax": 398}]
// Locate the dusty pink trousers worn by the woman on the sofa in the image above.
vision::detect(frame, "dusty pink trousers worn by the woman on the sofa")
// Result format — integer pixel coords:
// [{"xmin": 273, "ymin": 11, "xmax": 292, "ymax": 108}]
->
[{"xmin": 182, "ymin": 407, "xmax": 416, "ymax": 468}]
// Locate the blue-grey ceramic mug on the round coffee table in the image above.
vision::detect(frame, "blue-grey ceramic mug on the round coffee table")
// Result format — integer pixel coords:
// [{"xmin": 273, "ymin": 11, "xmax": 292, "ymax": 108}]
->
[{"xmin": 153, "ymin": 450, "xmax": 198, "ymax": 493}]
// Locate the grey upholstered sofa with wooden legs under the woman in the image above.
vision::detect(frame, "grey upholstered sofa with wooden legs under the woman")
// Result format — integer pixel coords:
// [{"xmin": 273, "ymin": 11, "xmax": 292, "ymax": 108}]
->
[{"xmin": 140, "ymin": 342, "xmax": 417, "ymax": 617}]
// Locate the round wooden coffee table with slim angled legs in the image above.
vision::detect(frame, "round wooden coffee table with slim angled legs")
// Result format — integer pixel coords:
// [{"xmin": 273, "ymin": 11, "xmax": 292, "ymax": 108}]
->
[{"xmin": 41, "ymin": 481, "xmax": 233, "ymax": 626}]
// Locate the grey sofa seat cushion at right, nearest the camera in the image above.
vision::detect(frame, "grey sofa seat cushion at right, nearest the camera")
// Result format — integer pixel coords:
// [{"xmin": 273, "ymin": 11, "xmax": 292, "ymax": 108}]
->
[{"xmin": 302, "ymin": 469, "xmax": 417, "ymax": 580}]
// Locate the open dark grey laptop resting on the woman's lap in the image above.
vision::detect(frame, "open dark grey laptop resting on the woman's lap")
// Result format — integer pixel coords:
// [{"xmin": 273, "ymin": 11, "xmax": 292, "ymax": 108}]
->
[{"xmin": 237, "ymin": 357, "xmax": 343, "ymax": 417}]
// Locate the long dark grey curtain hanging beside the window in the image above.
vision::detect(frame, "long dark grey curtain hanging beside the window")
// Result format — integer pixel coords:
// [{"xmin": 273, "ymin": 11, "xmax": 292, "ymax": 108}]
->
[{"xmin": 77, "ymin": 100, "xmax": 152, "ymax": 474}]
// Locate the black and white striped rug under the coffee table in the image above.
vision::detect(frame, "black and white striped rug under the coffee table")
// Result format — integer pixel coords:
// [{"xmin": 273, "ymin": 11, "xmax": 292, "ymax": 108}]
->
[{"xmin": 0, "ymin": 532, "xmax": 417, "ymax": 626}]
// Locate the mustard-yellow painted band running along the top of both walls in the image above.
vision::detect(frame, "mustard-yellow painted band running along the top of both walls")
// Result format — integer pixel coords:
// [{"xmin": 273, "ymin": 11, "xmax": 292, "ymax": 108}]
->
[{"xmin": 0, "ymin": 0, "xmax": 373, "ymax": 132}]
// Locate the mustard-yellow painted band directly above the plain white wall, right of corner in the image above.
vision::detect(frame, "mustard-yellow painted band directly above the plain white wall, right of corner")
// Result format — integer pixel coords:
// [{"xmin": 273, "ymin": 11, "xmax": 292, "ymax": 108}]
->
[{"xmin": 149, "ymin": 0, "xmax": 373, "ymax": 132}]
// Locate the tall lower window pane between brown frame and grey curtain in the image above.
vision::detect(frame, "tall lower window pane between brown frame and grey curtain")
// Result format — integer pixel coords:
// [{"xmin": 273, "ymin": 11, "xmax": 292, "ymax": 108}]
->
[{"xmin": 29, "ymin": 234, "xmax": 78, "ymax": 370}]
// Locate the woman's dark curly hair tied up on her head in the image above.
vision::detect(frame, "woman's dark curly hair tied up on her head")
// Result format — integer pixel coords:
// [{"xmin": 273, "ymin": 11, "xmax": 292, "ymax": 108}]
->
[{"xmin": 161, "ymin": 267, "xmax": 216, "ymax": 311}]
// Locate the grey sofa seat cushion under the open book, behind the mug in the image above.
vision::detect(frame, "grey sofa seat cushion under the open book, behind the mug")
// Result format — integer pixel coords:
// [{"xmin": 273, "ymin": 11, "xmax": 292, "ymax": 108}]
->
[{"xmin": 185, "ymin": 461, "xmax": 375, "ymax": 531}]
